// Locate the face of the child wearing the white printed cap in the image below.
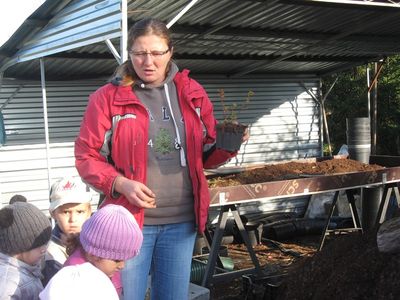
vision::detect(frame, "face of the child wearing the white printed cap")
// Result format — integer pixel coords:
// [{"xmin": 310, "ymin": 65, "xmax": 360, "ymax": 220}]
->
[{"xmin": 51, "ymin": 203, "xmax": 92, "ymax": 236}]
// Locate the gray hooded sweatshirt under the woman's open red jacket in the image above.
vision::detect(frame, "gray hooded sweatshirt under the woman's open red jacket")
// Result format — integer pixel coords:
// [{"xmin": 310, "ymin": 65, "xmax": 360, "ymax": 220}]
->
[{"xmin": 134, "ymin": 63, "xmax": 194, "ymax": 225}]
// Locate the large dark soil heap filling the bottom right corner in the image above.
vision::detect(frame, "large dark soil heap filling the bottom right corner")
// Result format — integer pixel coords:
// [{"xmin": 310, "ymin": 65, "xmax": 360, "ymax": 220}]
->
[{"xmin": 276, "ymin": 232, "xmax": 400, "ymax": 300}]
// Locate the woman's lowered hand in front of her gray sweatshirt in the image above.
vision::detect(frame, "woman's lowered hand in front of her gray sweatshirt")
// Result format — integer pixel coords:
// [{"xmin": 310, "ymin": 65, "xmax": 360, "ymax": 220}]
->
[{"xmin": 114, "ymin": 176, "xmax": 156, "ymax": 208}]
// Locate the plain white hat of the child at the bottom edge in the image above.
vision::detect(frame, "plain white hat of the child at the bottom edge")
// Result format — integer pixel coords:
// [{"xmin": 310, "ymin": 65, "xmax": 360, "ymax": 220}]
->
[{"xmin": 39, "ymin": 262, "xmax": 119, "ymax": 300}]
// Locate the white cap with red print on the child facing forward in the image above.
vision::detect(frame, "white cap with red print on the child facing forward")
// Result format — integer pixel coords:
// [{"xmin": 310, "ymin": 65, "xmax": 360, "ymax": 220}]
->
[{"xmin": 49, "ymin": 177, "xmax": 92, "ymax": 211}]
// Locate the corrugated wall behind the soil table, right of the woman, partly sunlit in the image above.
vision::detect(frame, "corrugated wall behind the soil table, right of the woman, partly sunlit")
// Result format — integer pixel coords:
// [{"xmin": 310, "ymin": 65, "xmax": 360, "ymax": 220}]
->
[{"xmin": 198, "ymin": 77, "xmax": 321, "ymax": 166}]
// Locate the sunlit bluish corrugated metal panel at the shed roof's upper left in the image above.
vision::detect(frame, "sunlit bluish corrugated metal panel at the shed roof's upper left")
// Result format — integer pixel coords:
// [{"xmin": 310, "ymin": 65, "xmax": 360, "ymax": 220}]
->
[{"xmin": 18, "ymin": 0, "xmax": 121, "ymax": 62}]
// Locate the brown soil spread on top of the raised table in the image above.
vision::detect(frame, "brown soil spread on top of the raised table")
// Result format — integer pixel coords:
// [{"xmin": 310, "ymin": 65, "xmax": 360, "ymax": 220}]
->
[{"xmin": 208, "ymin": 159, "xmax": 384, "ymax": 188}]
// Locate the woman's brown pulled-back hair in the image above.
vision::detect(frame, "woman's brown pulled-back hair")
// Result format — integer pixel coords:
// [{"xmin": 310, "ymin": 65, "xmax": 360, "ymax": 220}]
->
[{"xmin": 113, "ymin": 18, "xmax": 172, "ymax": 80}]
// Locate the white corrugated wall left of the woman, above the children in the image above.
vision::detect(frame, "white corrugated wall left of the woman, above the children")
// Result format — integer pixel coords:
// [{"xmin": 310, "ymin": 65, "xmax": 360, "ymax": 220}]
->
[{"xmin": 0, "ymin": 81, "xmax": 104, "ymax": 210}]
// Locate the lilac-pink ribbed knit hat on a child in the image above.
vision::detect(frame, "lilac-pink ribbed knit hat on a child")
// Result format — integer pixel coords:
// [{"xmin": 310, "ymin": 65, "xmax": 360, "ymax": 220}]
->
[{"xmin": 80, "ymin": 204, "xmax": 143, "ymax": 260}]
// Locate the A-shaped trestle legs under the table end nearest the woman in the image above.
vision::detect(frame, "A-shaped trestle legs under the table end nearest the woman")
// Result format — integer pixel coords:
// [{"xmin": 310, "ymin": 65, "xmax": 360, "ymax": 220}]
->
[{"xmin": 201, "ymin": 204, "xmax": 262, "ymax": 287}]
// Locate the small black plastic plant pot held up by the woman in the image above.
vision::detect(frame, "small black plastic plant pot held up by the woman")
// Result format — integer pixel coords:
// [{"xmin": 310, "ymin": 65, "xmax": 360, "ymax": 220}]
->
[{"xmin": 216, "ymin": 123, "xmax": 247, "ymax": 152}]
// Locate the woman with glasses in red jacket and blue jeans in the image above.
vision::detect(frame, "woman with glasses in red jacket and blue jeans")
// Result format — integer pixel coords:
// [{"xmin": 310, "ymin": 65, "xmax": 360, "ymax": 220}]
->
[{"xmin": 75, "ymin": 19, "xmax": 248, "ymax": 300}]
